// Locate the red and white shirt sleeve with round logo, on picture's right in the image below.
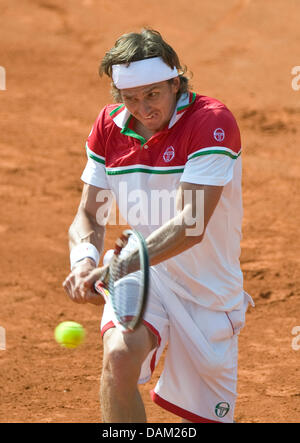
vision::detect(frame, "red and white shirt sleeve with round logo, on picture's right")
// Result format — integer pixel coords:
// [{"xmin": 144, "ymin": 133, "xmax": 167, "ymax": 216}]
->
[{"xmin": 181, "ymin": 107, "xmax": 241, "ymax": 186}]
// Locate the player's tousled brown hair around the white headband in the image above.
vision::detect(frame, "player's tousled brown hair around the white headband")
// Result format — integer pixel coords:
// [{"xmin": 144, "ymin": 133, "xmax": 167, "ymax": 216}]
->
[{"xmin": 99, "ymin": 29, "xmax": 190, "ymax": 102}]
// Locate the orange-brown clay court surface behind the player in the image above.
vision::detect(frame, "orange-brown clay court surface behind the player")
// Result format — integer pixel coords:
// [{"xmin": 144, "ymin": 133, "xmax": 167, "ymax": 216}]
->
[{"xmin": 0, "ymin": 0, "xmax": 300, "ymax": 423}]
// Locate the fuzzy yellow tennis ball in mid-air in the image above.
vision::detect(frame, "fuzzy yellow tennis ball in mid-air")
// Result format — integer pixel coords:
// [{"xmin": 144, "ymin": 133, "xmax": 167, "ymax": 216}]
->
[{"xmin": 54, "ymin": 321, "xmax": 85, "ymax": 348}]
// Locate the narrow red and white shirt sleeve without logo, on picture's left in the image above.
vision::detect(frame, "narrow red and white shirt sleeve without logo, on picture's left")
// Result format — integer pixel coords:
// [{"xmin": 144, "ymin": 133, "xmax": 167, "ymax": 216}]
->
[{"xmin": 81, "ymin": 108, "xmax": 110, "ymax": 189}]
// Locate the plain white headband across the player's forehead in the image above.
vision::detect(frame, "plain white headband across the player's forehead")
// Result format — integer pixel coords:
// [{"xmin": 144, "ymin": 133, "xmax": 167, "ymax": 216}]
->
[{"xmin": 112, "ymin": 57, "xmax": 178, "ymax": 89}]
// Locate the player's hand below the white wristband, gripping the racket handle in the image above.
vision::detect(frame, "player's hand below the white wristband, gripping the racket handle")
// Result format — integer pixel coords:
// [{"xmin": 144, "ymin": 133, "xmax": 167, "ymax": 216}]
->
[{"xmin": 63, "ymin": 258, "xmax": 104, "ymax": 305}]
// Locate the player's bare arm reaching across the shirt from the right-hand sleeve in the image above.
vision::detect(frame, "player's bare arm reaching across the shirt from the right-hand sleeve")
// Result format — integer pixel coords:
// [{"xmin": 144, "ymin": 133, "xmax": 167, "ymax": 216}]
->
[{"xmin": 85, "ymin": 182, "xmax": 223, "ymax": 288}]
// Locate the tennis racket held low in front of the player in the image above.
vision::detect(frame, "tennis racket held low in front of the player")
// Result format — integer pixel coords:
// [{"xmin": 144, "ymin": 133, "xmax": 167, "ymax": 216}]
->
[{"xmin": 94, "ymin": 229, "xmax": 149, "ymax": 331}]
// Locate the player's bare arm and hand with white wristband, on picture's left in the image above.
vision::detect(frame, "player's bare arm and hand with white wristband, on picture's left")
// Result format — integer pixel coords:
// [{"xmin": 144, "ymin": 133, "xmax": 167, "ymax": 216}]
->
[{"xmin": 63, "ymin": 184, "xmax": 112, "ymax": 305}]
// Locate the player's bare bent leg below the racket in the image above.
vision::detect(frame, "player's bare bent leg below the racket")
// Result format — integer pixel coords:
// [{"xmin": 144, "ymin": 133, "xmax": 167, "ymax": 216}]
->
[{"xmin": 100, "ymin": 325, "xmax": 157, "ymax": 423}]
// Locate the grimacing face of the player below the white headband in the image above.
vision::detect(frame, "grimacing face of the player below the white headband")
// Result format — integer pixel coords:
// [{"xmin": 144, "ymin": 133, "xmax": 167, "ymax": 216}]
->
[{"xmin": 121, "ymin": 77, "xmax": 179, "ymax": 133}]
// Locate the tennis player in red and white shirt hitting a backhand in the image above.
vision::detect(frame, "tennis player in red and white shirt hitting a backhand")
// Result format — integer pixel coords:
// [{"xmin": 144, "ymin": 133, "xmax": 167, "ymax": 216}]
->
[{"xmin": 63, "ymin": 29, "xmax": 253, "ymax": 423}]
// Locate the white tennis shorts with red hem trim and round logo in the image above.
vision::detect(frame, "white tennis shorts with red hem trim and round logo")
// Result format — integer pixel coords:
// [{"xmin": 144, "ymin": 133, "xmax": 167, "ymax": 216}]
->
[{"xmin": 101, "ymin": 268, "xmax": 253, "ymax": 423}]
